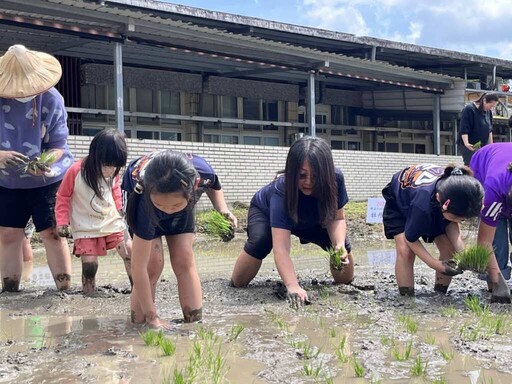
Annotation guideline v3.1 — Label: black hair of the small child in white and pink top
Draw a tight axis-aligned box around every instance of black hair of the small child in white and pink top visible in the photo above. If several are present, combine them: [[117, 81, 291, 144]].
[[82, 128, 128, 200]]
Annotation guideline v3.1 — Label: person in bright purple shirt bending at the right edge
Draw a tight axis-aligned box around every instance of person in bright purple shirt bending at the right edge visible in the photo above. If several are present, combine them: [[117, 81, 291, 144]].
[[470, 143, 512, 302]]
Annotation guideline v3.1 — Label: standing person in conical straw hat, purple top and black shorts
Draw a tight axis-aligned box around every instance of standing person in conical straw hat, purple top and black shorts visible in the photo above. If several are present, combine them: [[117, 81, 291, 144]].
[[0, 45, 73, 292]]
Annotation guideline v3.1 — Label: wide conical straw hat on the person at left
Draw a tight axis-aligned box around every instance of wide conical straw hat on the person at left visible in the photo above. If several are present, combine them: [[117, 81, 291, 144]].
[[0, 45, 62, 99]]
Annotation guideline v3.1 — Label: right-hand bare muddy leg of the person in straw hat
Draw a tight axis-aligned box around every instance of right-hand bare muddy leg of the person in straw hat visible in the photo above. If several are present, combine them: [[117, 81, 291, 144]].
[[40, 227, 71, 290]]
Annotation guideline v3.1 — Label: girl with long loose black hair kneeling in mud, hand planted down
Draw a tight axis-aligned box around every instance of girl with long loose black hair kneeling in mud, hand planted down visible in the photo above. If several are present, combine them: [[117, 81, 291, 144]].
[[231, 137, 354, 307]]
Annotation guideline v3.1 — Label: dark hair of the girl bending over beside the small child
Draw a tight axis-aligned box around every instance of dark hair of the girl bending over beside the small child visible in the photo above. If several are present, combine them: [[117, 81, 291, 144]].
[[126, 150, 199, 228]]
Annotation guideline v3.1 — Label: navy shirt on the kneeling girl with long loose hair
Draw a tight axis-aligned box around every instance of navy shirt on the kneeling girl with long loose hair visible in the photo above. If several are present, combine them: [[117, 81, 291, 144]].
[[251, 169, 348, 231]]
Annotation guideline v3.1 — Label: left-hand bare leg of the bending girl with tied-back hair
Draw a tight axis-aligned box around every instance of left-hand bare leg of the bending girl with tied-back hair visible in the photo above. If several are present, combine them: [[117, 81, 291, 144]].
[[395, 233, 416, 296]]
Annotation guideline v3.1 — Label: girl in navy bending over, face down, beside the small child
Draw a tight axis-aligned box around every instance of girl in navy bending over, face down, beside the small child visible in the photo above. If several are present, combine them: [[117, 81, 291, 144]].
[[121, 150, 237, 328]]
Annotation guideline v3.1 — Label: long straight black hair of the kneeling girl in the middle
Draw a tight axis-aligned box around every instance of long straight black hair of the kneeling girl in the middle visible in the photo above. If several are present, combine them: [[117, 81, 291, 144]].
[[284, 136, 338, 225]]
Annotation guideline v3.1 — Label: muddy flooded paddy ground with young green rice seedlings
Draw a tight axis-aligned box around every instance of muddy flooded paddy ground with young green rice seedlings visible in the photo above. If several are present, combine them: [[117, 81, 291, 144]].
[[0, 239, 512, 383]]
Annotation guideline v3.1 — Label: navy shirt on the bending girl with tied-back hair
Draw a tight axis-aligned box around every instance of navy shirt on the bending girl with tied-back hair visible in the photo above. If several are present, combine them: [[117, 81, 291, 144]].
[[391, 164, 450, 243]]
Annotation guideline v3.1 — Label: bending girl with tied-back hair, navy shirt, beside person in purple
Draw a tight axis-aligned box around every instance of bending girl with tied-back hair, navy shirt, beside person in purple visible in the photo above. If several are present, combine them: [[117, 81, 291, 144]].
[[382, 164, 484, 296]]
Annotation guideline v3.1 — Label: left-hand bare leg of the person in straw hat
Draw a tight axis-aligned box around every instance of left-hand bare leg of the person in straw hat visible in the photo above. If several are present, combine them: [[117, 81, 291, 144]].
[[0, 227, 25, 292]]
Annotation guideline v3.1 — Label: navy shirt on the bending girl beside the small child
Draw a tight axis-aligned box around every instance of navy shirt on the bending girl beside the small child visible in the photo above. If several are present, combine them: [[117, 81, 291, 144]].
[[121, 151, 221, 240]]
